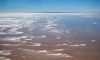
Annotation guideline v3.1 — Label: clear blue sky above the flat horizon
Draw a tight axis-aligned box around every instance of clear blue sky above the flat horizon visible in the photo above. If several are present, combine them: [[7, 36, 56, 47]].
[[0, 0, 100, 12]]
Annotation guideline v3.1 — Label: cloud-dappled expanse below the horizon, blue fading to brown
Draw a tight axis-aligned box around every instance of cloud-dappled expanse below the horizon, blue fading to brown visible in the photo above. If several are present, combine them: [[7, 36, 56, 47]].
[[0, 13, 100, 60]]
